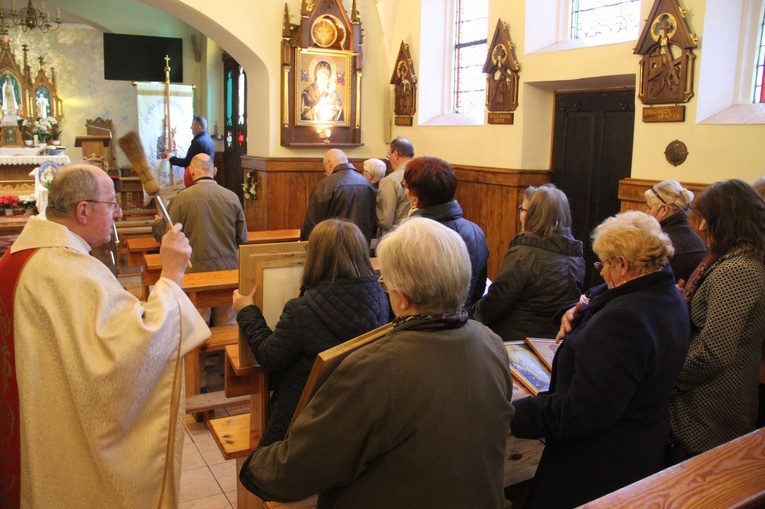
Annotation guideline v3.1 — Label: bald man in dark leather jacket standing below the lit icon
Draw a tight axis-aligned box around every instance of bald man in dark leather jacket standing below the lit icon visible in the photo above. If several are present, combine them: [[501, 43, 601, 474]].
[[300, 148, 377, 242]]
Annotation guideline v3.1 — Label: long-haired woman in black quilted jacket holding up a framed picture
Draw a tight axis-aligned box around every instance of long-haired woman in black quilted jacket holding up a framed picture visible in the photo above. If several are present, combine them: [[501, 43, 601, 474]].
[[234, 219, 388, 445]]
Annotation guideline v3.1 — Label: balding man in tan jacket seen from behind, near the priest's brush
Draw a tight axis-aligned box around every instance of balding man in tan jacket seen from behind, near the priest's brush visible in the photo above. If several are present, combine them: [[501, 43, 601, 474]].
[[152, 154, 247, 325]]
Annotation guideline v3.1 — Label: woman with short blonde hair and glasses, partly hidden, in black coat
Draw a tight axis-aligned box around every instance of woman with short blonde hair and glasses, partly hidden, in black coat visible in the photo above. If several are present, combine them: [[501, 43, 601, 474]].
[[645, 180, 707, 281]]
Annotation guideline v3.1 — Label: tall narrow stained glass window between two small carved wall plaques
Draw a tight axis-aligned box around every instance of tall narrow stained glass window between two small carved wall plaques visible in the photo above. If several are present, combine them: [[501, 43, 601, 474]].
[[453, 0, 489, 114]]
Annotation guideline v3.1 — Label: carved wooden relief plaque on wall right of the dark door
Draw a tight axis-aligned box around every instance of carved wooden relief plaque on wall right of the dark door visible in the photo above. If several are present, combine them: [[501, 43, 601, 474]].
[[635, 0, 698, 122]]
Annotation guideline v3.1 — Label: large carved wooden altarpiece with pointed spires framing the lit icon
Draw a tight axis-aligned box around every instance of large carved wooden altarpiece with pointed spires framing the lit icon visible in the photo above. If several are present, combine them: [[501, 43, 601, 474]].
[[281, 0, 363, 147]]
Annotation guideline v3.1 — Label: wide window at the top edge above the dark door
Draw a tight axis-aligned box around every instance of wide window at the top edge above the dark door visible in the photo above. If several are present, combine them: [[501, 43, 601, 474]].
[[570, 0, 640, 39]]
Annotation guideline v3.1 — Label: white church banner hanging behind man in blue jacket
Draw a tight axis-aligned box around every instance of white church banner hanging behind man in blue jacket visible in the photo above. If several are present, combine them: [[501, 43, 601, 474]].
[[136, 83, 194, 187]]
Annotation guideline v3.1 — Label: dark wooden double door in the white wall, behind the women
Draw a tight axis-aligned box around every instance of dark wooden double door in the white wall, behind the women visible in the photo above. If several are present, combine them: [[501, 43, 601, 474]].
[[552, 90, 635, 289]]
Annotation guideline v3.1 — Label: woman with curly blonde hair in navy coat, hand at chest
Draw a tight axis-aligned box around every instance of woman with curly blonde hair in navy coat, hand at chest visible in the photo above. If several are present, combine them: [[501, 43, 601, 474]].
[[511, 211, 690, 508]]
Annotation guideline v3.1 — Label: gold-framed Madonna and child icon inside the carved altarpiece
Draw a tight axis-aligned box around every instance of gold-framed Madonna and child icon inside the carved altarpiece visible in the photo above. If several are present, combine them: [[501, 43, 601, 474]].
[[295, 49, 351, 127]]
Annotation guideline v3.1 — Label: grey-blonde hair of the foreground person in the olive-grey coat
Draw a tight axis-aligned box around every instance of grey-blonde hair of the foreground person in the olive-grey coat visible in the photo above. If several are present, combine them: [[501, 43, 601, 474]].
[[377, 217, 471, 314]]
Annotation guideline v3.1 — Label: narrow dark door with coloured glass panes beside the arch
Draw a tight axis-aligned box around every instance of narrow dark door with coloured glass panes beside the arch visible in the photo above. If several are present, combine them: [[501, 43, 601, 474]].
[[222, 53, 247, 200]]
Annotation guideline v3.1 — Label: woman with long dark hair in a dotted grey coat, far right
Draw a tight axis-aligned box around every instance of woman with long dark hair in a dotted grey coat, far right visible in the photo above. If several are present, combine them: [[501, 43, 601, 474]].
[[670, 180, 765, 460]]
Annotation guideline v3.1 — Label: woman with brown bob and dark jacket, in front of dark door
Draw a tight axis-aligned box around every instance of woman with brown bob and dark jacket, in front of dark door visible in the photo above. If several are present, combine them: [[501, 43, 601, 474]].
[[474, 184, 584, 341]]
